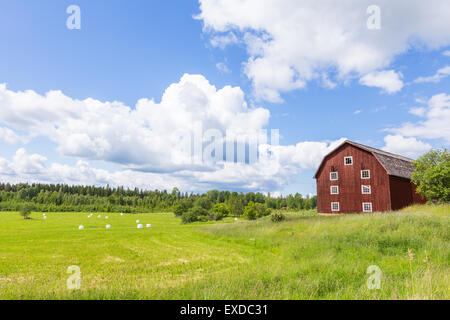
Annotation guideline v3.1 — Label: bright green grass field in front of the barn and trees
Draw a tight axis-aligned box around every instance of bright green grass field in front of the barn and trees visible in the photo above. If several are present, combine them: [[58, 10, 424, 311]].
[[0, 206, 450, 299]]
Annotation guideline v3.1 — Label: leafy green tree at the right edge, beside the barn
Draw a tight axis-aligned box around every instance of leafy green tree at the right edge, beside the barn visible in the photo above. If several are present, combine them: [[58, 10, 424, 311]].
[[411, 148, 450, 202]]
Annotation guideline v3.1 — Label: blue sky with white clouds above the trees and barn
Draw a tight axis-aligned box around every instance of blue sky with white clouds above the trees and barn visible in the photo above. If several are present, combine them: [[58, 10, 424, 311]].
[[0, 0, 450, 194]]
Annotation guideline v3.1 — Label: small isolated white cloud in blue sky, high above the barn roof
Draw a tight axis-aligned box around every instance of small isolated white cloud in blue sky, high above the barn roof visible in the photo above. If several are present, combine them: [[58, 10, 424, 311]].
[[359, 70, 403, 94]]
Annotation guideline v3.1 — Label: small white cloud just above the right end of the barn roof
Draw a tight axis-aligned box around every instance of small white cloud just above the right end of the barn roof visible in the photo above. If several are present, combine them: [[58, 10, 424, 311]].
[[383, 135, 431, 158]]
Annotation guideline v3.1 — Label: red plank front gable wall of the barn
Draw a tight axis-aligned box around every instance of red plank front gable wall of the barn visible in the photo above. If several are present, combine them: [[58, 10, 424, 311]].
[[317, 144, 390, 213]]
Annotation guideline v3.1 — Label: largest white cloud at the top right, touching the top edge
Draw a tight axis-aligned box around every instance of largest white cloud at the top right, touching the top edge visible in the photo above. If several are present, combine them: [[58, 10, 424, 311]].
[[197, 0, 450, 102]]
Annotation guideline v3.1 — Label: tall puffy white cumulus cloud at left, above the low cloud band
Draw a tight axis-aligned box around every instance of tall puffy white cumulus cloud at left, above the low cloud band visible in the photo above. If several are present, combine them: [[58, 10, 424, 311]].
[[0, 75, 270, 171]]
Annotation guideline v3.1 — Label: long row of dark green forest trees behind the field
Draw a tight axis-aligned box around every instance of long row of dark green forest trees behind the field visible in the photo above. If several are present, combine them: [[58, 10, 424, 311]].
[[0, 183, 317, 216]]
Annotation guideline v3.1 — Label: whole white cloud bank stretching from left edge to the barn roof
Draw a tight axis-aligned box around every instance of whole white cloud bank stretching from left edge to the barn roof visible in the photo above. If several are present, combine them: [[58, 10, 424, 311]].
[[0, 75, 346, 191]]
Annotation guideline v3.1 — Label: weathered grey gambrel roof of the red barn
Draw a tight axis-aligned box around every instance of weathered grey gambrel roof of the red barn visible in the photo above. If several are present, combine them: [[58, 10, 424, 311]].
[[314, 140, 414, 179]]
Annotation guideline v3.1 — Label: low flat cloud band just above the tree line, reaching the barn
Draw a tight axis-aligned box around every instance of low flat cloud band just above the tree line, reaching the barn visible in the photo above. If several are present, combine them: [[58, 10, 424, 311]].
[[0, 139, 345, 192]]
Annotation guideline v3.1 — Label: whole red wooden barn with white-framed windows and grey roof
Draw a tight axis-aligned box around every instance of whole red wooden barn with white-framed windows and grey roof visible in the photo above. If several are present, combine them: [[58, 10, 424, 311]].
[[314, 140, 425, 213]]
